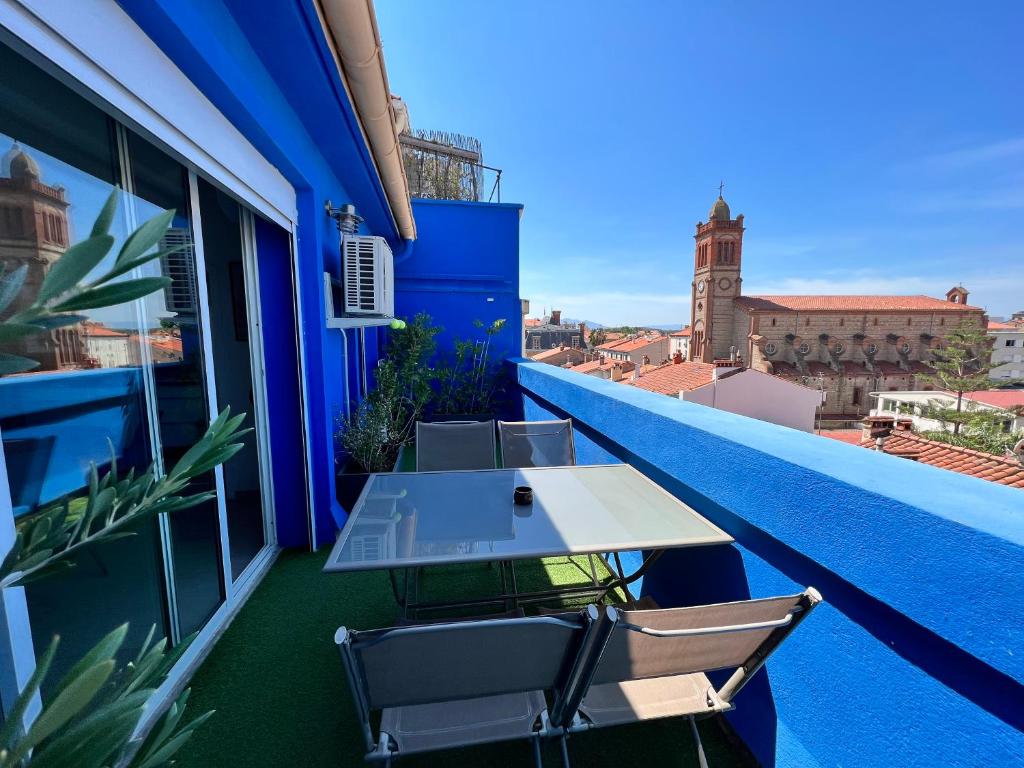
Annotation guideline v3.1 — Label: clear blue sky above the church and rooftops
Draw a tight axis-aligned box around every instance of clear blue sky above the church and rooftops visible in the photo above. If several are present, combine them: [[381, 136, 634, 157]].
[[377, 0, 1024, 325]]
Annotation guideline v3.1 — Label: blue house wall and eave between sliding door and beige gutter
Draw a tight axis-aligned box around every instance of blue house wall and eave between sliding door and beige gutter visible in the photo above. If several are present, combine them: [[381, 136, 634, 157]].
[[120, 0, 402, 546]]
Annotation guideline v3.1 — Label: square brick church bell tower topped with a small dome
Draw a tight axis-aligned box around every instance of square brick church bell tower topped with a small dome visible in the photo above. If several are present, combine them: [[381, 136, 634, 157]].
[[689, 185, 743, 362]]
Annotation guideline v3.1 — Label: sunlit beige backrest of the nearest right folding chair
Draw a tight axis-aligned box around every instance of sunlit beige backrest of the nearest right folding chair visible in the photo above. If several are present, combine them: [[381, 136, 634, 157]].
[[552, 587, 821, 725]]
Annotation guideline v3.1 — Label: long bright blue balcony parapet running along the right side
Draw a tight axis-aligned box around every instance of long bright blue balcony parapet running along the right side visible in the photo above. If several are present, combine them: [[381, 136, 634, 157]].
[[516, 360, 1024, 768]]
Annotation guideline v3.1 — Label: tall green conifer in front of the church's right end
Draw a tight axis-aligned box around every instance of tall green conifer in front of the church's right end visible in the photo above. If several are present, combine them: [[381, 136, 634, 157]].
[[924, 319, 993, 434]]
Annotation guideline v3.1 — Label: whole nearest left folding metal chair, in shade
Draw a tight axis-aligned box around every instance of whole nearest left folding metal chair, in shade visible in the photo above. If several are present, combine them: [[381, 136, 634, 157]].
[[335, 605, 600, 766]]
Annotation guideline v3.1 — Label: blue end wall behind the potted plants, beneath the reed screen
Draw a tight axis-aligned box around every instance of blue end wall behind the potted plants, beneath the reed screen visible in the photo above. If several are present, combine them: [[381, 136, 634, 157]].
[[395, 200, 522, 380]]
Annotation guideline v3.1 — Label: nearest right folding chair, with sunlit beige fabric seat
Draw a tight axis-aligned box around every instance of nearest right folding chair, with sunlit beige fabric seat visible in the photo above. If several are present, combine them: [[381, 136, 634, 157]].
[[551, 588, 821, 768]]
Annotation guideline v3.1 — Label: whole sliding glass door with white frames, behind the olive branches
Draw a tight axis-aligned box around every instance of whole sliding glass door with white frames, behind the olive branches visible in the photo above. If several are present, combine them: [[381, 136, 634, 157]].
[[0, 39, 273, 693]]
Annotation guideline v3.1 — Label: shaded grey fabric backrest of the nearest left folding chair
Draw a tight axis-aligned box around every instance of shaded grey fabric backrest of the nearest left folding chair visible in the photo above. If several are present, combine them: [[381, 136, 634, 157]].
[[335, 606, 597, 710]]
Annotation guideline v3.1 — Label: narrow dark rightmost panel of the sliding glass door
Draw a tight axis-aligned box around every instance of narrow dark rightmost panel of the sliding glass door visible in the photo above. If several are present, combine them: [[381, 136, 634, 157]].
[[199, 179, 266, 579]]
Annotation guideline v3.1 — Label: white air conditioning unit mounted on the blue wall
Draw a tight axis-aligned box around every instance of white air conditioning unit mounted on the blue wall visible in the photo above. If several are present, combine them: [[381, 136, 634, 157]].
[[341, 234, 394, 317]]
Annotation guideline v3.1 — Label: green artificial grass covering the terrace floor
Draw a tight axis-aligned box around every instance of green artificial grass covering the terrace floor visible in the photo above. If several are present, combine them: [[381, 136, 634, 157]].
[[177, 551, 753, 768]]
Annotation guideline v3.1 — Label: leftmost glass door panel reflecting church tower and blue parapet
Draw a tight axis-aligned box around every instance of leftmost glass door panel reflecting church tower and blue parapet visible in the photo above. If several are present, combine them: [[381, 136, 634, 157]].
[[0, 40, 168, 693]]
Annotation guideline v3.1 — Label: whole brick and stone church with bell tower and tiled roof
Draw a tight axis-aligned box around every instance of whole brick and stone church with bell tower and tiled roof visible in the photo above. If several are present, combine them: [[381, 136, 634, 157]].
[[688, 195, 987, 420]]
